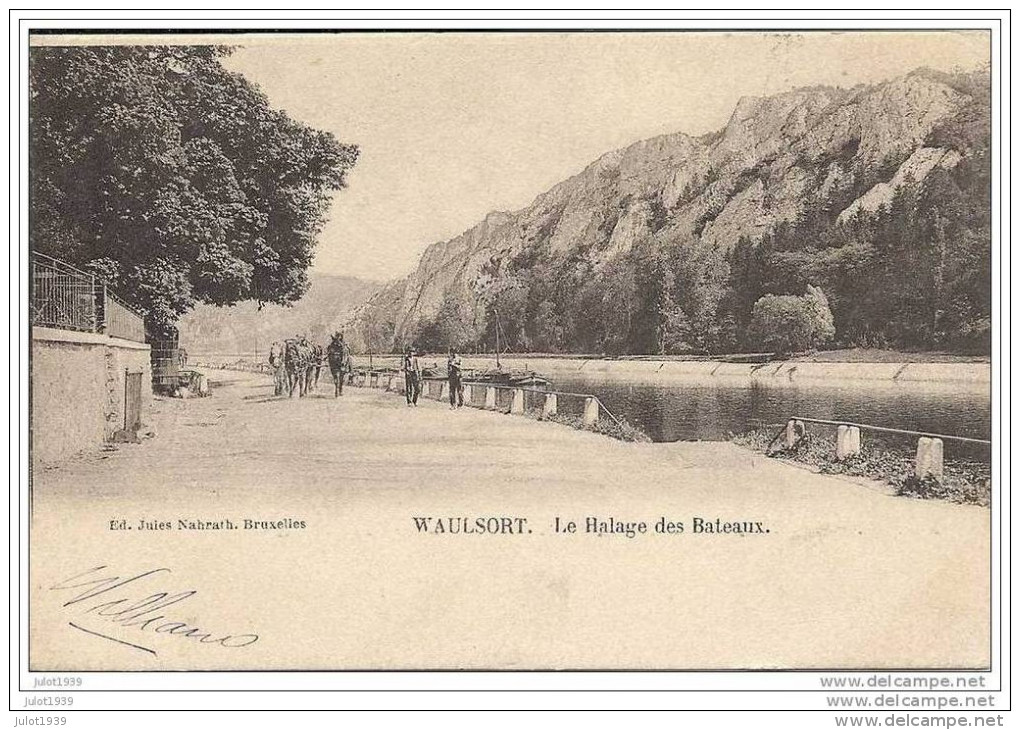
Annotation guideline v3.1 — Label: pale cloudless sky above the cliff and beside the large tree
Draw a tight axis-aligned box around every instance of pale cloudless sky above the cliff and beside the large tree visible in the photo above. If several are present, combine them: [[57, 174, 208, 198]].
[[215, 32, 989, 280]]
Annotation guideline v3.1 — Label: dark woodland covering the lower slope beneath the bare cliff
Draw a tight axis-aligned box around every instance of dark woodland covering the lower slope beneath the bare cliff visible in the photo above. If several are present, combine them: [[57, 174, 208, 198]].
[[465, 131, 991, 354]]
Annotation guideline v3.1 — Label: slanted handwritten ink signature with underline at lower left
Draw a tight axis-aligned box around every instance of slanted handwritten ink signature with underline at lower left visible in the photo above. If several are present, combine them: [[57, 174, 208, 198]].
[[50, 565, 259, 656]]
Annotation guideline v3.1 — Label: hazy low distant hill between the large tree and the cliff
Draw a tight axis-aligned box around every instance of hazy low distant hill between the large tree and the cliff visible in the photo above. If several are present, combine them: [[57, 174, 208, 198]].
[[177, 273, 381, 355]]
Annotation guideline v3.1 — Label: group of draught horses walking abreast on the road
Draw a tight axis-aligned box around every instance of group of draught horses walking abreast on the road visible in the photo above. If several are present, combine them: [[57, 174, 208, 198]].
[[269, 331, 353, 398]]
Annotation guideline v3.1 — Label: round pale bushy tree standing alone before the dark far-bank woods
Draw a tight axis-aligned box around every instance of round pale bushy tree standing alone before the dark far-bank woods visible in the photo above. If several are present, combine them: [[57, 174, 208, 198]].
[[751, 286, 835, 355]]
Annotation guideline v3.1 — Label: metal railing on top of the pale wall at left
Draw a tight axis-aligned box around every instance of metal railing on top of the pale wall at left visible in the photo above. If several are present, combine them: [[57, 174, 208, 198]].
[[29, 252, 145, 343]]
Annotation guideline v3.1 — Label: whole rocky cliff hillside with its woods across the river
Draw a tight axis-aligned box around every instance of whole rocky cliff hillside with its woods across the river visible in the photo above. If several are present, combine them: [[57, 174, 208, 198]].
[[353, 69, 991, 354]]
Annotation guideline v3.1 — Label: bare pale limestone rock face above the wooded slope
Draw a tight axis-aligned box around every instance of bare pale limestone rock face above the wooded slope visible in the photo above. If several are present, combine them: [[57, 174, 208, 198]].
[[356, 69, 986, 345]]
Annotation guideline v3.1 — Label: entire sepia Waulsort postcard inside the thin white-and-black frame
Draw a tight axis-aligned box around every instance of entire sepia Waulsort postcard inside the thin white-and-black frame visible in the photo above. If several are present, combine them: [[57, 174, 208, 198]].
[[26, 28, 1005, 672]]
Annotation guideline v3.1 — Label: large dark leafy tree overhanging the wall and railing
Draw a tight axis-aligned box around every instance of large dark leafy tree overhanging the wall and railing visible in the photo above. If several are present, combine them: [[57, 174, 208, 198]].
[[29, 46, 358, 331]]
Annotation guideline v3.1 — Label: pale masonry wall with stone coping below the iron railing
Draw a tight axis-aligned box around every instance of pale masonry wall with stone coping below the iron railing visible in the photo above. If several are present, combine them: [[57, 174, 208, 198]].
[[30, 327, 152, 462]]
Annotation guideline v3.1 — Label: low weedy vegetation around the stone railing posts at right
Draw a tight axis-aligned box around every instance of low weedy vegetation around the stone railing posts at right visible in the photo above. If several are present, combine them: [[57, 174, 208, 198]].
[[731, 426, 991, 507]]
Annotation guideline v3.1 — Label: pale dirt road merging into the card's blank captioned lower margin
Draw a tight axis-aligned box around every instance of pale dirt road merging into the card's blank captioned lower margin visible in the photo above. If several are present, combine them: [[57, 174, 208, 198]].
[[32, 371, 989, 670]]
